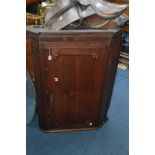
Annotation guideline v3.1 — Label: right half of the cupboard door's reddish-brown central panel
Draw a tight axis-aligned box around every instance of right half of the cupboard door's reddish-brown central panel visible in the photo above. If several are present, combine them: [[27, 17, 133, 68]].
[[76, 48, 109, 123]]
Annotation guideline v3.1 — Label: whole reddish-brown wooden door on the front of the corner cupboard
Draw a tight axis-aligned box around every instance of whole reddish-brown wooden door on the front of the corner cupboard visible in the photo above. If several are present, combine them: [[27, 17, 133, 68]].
[[45, 46, 109, 125]]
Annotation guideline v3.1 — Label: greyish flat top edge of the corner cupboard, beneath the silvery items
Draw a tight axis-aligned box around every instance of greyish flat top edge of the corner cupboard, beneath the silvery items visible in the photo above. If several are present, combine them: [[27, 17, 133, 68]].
[[26, 27, 120, 34]]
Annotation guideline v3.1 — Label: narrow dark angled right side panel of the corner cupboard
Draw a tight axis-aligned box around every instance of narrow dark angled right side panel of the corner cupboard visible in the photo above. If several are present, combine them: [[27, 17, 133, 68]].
[[100, 31, 122, 124]]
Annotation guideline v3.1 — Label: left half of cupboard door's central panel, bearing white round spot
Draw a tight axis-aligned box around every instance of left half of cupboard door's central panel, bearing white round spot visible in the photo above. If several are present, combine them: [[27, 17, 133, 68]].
[[47, 55, 76, 123]]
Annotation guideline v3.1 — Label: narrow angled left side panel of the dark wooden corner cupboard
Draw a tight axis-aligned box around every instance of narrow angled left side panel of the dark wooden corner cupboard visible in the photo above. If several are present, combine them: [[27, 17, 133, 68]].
[[30, 33, 48, 129]]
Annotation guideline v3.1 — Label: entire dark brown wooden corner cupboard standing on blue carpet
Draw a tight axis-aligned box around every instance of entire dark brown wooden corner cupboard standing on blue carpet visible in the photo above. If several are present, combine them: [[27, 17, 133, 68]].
[[27, 28, 121, 132]]
